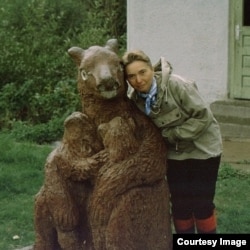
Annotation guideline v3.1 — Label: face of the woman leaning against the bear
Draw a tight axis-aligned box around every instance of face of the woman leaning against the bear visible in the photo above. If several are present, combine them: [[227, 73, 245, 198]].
[[125, 61, 154, 93]]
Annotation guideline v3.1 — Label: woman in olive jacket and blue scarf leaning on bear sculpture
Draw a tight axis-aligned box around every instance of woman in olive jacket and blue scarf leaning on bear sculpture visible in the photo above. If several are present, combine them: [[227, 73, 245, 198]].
[[122, 50, 222, 233]]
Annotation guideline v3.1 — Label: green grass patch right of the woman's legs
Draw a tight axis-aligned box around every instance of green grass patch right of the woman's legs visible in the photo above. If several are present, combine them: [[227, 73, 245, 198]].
[[215, 163, 250, 234]]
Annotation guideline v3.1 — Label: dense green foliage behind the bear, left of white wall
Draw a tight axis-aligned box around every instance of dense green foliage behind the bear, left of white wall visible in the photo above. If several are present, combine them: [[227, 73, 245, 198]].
[[0, 0, 126, 141]]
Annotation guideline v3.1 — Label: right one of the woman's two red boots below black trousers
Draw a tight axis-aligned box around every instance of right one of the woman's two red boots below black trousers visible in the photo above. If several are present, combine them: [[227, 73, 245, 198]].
[[195, 212, 217, 234]]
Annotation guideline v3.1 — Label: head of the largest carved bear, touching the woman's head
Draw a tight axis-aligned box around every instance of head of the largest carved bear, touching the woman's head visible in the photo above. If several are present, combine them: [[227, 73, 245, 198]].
[[68, 39, 127, 99]]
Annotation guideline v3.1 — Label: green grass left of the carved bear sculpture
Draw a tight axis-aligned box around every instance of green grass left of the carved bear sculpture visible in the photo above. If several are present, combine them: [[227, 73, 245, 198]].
[[0, 134, 51, 250]]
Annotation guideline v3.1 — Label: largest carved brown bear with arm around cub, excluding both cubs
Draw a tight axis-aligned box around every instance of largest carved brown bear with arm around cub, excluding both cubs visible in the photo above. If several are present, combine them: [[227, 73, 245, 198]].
[[68, 39, 172, 250]]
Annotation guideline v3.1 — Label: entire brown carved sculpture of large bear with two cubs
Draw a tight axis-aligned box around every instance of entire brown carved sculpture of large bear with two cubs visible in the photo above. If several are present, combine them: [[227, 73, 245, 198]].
[[34, 39, 172, 250]]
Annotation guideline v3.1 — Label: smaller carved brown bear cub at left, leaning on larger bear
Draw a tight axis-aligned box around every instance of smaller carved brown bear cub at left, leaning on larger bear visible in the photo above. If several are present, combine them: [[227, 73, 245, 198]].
[[34, 112, 102, 250]]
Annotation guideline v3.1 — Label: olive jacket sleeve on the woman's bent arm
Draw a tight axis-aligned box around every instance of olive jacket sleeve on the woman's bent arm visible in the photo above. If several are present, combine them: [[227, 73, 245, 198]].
[[168, 79, 213, 142]]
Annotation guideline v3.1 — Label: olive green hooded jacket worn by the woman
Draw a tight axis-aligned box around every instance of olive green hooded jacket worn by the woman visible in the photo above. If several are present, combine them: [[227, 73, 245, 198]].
[[130, 57, 222, 160]]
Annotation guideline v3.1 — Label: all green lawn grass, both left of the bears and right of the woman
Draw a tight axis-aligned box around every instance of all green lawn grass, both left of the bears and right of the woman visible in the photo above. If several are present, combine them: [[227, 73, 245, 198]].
[[0, 134, 250, 250]]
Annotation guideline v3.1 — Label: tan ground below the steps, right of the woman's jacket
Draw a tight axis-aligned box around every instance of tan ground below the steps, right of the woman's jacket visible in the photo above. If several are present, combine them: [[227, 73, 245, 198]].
[[222, 139, 250, 173]]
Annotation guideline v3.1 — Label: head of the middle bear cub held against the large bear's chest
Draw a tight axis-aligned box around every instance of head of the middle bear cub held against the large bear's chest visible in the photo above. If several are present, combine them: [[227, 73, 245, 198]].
[[98, 116, 139, 162]]
